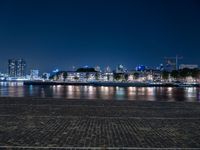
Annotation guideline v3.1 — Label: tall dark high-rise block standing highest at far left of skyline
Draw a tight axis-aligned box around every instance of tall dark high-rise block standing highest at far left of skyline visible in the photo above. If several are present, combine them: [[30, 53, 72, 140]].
[[8, 59, 26, 77]]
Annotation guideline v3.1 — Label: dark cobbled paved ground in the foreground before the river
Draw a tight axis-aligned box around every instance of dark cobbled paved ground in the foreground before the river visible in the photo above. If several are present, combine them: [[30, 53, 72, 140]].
[[0, 98, 200, 149]]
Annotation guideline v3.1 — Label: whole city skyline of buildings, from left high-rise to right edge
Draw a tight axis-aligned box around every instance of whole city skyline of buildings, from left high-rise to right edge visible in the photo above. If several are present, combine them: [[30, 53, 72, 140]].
[[0, 57, 199, 82]]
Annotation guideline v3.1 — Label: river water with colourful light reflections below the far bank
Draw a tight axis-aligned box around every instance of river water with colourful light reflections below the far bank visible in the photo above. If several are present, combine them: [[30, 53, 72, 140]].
[[0, 82, 200, 102]]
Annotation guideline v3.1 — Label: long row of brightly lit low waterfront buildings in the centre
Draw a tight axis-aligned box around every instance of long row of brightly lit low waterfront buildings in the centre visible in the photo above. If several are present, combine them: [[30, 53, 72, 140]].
[[52, 65, 161, 82]]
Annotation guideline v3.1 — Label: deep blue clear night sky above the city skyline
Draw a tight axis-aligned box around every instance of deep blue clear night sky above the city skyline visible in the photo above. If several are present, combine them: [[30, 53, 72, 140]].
[[0, 0, 200, 71]]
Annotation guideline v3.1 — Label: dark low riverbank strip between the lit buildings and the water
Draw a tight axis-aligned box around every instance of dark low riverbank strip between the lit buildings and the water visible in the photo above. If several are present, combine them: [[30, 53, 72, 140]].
[[24, 81, 200, 87]]
